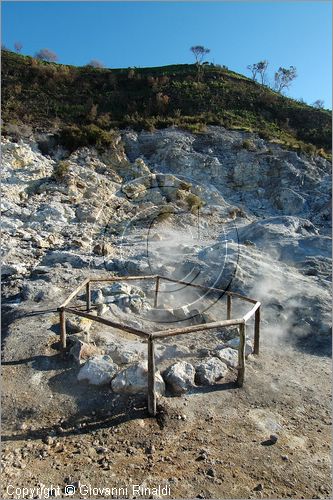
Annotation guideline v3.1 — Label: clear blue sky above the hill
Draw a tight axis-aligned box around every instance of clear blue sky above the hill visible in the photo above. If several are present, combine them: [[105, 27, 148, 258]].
[[2, 0, 332, 108]]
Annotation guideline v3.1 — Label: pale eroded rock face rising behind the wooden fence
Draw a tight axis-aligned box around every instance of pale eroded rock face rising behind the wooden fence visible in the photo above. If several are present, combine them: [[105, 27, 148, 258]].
[[2, 127, 331, 406]]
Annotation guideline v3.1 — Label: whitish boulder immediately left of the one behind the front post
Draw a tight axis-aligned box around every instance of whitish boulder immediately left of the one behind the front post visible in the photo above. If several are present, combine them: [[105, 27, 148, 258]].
[[77, 356, 118, 385]]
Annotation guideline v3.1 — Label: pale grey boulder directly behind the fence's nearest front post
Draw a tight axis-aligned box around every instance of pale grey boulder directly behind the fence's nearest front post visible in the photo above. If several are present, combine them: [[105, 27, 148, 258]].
[[111, 363, 165, 395]]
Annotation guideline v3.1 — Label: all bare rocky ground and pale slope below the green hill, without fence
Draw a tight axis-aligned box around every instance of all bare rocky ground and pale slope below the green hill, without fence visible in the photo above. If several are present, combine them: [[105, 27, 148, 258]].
[[2, 126, 331, 498]]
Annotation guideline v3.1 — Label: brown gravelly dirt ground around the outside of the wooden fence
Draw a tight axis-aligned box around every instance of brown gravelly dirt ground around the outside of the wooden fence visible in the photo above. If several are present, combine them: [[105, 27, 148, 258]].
[[1, 300, 332, 499]]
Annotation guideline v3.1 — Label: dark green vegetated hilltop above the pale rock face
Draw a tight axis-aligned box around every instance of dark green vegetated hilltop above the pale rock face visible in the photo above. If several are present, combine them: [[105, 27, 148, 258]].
[[2, 50, 331, 156]]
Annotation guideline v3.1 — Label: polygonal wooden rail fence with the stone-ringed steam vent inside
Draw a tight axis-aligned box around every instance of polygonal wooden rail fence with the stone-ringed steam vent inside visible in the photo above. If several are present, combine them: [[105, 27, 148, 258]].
[[58, 275, 260, 416]]
